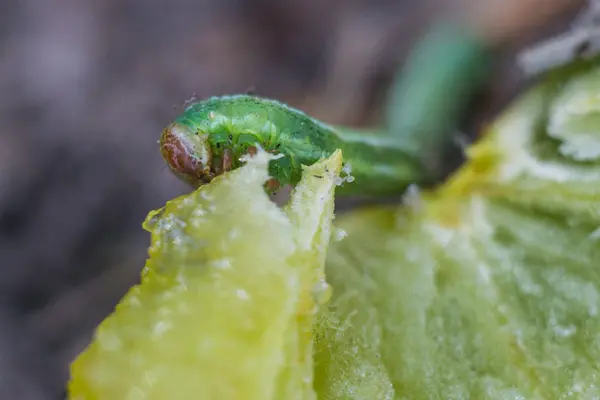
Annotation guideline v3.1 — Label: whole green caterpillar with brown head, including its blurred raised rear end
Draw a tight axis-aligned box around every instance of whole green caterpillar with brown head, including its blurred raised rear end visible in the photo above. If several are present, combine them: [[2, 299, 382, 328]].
[[161, 24, 490, 197]]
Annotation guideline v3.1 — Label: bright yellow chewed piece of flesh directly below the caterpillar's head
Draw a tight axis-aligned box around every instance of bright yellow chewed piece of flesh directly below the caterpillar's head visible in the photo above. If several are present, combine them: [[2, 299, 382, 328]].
[[69, 152, 342, 400]]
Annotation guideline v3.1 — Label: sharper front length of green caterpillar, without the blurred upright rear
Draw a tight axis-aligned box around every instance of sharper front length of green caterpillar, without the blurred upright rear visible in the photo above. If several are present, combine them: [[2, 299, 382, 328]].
[[160, 95, 427, 196]]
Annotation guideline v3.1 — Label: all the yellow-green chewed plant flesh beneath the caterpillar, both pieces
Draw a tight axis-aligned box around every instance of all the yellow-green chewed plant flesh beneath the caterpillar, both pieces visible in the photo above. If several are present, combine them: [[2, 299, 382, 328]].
[[71, 59, 600, 399]]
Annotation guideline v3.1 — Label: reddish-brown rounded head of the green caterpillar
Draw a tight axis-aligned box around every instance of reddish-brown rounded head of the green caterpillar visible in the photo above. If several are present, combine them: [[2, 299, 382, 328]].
[[160, 122, 218, 187]]
